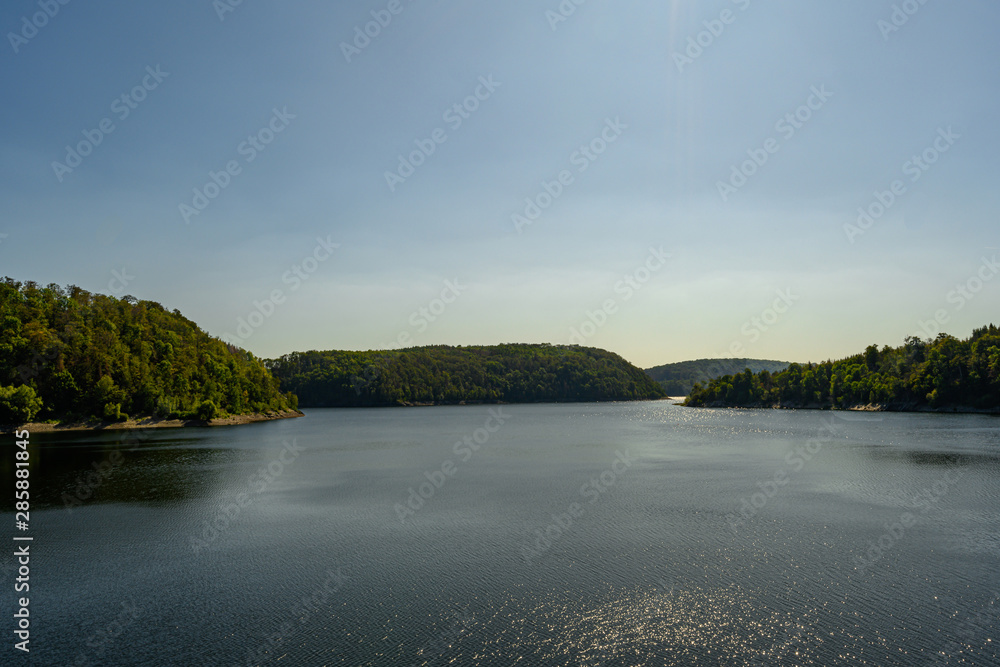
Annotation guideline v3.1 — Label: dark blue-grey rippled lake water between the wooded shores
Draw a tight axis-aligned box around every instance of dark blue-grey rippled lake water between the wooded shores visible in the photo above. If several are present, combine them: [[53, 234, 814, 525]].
[[0, 402, 1000, 667]]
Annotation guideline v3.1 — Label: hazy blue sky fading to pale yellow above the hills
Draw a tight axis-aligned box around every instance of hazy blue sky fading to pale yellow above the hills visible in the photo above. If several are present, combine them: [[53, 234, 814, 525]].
[[0, 0, 1000, 367]]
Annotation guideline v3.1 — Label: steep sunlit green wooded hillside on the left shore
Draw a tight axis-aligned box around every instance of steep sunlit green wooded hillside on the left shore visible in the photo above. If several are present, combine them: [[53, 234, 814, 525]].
[[0, 278, 295, 424]]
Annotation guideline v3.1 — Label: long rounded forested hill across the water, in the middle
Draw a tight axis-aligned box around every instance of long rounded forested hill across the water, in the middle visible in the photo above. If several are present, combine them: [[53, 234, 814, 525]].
[[267, 344, 664, 407]]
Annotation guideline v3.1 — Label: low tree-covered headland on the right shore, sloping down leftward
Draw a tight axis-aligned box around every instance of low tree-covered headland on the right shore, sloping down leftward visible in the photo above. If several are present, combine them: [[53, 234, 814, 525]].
[[685, 324, 1000, 411]]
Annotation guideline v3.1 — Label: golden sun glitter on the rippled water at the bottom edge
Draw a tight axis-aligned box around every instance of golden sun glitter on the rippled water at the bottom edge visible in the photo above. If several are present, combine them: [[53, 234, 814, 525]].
[[449, 585, 822, 667]]
